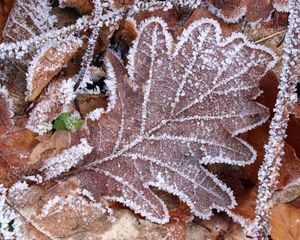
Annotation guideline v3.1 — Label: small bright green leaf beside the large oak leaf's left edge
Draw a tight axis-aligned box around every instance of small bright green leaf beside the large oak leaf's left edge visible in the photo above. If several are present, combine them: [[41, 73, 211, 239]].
[[53, 112, 83, 130]]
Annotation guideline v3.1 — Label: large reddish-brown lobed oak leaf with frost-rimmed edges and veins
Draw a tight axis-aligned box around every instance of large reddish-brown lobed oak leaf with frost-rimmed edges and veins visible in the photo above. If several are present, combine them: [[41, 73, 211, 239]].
[[73, 18, 276, 223]]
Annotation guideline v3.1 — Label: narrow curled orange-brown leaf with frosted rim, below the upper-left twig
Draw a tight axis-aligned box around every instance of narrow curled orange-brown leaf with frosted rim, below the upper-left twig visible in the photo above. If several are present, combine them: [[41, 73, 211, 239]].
[[26, 38, 81, 102]]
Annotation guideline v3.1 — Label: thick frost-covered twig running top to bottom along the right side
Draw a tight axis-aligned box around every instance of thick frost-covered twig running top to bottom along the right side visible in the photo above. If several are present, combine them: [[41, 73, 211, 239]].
[[254, 0, 300, 239]]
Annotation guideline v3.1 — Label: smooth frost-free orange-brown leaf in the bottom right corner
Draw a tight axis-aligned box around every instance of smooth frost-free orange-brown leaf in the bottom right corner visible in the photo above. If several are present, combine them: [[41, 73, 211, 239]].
[[271, 204, 300, 240]]
